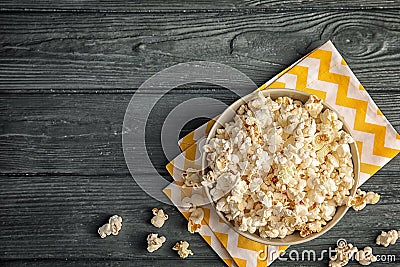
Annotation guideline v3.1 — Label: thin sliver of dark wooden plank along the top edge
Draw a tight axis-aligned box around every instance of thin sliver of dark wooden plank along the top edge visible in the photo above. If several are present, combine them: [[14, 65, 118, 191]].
[[0, 0, 400, 12]]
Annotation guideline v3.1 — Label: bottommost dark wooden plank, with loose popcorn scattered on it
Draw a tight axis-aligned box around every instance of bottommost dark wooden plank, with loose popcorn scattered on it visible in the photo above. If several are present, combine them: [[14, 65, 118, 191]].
[[0, 172, 400, 266]]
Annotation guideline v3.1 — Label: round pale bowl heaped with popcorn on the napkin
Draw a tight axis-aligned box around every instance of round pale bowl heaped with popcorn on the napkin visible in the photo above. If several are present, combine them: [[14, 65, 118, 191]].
[[202, 89, 359, 245]]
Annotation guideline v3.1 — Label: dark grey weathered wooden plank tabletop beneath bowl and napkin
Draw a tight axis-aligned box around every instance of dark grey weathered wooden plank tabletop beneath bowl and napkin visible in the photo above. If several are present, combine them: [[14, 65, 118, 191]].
[[0, 0, 400, 266]]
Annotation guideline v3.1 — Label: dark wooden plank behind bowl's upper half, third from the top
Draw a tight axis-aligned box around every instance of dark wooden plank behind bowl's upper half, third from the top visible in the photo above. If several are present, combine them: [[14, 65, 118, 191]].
[[0, 92, 400, 175]]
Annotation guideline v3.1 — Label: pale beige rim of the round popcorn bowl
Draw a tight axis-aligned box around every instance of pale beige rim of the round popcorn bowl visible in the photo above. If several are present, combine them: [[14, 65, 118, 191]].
[[201, 88, 360, 246]]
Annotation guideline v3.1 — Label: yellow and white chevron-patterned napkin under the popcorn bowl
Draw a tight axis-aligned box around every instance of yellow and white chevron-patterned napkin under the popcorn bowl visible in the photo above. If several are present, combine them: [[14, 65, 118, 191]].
[[164, 41, 400, 267]]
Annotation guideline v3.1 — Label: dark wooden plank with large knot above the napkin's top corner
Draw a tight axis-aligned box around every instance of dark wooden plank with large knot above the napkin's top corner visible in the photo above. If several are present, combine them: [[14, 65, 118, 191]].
[[0, 11, 400, 92]]
